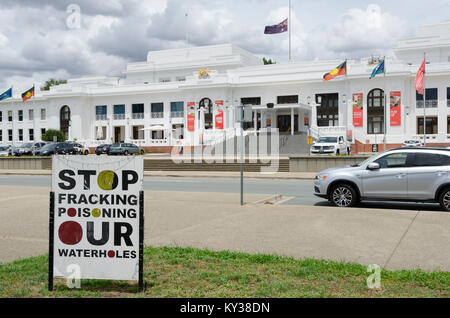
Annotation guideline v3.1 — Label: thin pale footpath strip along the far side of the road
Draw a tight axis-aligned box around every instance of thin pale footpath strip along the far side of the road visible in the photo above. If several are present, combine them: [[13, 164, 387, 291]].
[[0, 169, 317, 180]]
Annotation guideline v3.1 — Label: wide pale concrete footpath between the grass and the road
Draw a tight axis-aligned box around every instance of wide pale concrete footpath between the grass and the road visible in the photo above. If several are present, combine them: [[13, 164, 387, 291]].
[[0, 187, 450, 271]]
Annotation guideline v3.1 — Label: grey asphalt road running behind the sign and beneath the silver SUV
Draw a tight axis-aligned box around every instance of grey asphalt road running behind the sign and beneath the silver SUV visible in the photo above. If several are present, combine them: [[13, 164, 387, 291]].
[[0, 175, 440, 211]]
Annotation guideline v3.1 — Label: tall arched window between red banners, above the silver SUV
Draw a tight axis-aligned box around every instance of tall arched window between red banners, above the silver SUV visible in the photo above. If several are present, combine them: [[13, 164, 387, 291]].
[[367, 88, 384, 134]]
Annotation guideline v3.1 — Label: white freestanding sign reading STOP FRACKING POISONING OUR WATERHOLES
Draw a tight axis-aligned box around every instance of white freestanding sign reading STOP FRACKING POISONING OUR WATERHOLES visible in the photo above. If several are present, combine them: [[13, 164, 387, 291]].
[[49, 156, 144, 290]]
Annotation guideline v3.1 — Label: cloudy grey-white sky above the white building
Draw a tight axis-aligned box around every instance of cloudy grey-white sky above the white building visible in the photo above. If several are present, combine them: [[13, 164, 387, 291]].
[[0, 0, 450, 93]]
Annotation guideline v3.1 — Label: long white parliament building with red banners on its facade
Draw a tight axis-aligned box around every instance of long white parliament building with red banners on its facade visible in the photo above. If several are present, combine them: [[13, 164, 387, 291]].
[[0, 23, 450, 152]]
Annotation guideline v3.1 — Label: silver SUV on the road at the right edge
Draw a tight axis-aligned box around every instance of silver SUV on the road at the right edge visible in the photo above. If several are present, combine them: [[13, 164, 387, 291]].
[[314, 147, 450, 211]]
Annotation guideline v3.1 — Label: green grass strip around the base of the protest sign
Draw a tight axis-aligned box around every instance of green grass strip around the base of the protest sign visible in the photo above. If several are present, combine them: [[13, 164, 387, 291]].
[[0, 247, 450, 298]]
